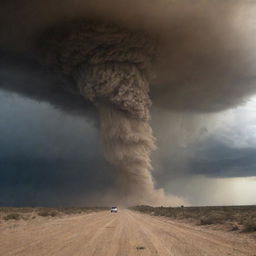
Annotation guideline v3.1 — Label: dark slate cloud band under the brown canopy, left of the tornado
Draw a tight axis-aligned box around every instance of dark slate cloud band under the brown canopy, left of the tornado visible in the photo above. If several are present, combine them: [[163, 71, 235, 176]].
[[0, 51, 95, 120]]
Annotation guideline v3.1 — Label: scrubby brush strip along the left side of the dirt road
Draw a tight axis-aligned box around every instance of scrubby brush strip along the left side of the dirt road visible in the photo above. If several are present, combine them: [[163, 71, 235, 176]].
[[0, 207, 108, 221]]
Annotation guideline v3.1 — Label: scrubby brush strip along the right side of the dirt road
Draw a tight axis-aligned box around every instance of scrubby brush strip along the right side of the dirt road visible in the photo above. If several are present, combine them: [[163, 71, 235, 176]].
[[131, 205, 256, 232]]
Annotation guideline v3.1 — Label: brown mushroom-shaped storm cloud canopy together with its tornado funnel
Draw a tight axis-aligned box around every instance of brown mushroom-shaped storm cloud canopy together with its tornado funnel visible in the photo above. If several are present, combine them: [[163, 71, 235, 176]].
[[0, 0, 256, 204]]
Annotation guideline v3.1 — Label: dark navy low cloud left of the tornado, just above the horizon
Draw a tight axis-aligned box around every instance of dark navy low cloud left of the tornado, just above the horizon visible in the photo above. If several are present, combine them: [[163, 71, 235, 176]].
[[0, 155, 114, 206]]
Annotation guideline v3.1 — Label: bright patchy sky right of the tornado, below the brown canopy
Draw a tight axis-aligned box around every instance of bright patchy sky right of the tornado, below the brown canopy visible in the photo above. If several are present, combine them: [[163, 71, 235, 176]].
[[152, 96, 256, 205]]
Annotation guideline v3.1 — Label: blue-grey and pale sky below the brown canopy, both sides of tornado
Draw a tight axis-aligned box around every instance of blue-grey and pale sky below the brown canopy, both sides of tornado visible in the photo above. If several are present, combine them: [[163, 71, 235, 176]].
[[0, 90, 256, 206]]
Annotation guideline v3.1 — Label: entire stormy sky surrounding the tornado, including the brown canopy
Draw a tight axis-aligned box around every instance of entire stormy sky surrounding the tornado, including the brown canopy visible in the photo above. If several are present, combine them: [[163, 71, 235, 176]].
[[0, 0, 256, 206]]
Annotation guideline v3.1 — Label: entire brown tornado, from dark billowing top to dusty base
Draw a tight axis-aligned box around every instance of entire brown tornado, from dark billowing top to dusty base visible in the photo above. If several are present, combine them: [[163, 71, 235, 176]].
[[40, 21, 164, 205]]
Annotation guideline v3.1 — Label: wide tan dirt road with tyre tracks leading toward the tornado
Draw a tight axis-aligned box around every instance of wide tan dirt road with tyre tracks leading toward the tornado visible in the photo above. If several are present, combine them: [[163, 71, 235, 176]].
[[0, 210, 256, 256]]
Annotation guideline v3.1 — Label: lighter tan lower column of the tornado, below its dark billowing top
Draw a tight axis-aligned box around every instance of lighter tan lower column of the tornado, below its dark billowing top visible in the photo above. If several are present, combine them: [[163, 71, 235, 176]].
[[97, 104, 167, 205]]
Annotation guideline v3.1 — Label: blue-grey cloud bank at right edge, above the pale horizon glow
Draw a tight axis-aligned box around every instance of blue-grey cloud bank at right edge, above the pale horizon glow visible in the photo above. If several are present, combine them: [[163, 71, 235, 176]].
[[190, 140, 256, 177]]
